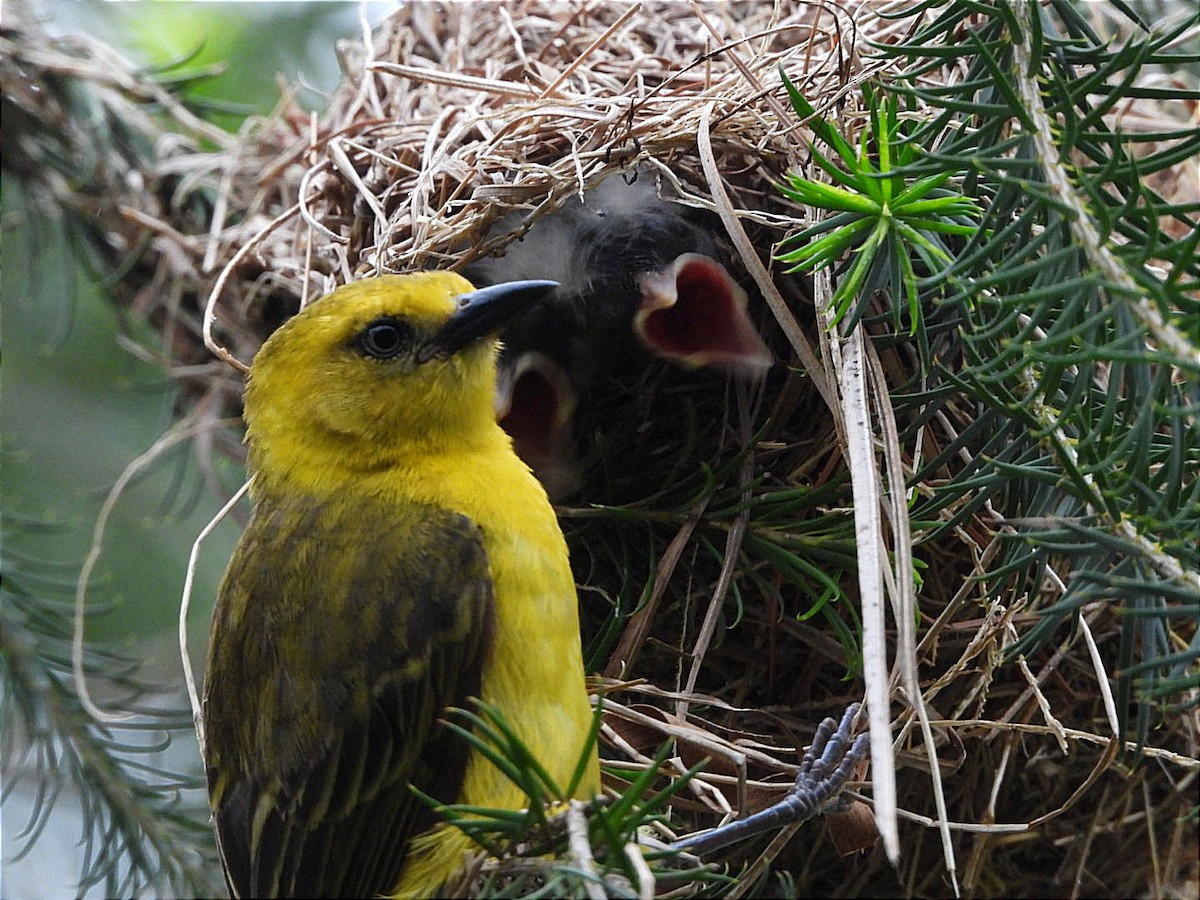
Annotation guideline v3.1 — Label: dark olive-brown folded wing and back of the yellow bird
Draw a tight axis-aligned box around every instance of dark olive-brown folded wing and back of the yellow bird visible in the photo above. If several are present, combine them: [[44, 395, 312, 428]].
[[204, 500, 493, 896]]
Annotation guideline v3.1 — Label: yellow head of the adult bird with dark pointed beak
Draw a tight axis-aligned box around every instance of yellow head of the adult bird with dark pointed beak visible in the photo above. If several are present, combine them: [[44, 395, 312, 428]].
[[245, 272, 554, 489]]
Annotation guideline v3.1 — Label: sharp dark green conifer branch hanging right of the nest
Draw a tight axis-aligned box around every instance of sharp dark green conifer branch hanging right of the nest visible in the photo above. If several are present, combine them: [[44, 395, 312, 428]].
[[868, 2, 1200, 738]]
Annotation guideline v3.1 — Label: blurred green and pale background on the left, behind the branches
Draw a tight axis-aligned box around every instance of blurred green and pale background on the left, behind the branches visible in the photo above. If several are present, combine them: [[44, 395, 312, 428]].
[[0, 0, 395, 900]]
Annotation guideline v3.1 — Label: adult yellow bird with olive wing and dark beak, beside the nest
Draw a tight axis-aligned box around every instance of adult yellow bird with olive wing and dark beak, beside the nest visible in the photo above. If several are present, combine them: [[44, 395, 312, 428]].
[[203, 272, 600, 896]]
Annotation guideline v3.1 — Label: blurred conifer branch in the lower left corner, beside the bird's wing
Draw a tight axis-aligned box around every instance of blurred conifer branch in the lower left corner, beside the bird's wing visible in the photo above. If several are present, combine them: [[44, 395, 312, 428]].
[[0, 573, 220, 895]]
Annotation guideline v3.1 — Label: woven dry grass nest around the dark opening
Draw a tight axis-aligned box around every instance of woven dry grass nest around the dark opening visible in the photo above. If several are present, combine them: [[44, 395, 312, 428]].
[[23, 2, 1187, 895]]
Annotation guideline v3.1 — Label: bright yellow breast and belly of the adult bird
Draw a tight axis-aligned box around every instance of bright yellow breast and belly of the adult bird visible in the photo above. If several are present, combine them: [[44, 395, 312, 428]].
[[298, 434, 600, 896]]
